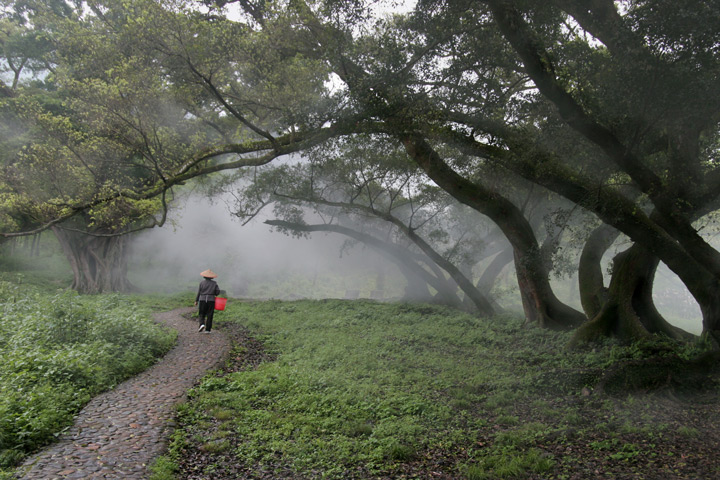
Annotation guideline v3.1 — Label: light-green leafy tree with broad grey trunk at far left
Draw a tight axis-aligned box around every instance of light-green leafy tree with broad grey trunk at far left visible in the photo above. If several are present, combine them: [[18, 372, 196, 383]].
[[2, 1, 198, 293]]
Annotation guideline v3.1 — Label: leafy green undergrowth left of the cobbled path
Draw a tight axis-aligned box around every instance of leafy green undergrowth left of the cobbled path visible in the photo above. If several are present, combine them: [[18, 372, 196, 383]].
[[0, 275, 175, 477]]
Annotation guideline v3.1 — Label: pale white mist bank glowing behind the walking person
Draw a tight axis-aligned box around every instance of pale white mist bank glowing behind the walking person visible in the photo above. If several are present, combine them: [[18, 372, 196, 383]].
[[128, 192, 404, 299]]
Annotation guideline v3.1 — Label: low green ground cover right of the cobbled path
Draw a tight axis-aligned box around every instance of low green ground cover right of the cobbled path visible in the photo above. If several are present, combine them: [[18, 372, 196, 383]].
[[159, 300, 720, 479]]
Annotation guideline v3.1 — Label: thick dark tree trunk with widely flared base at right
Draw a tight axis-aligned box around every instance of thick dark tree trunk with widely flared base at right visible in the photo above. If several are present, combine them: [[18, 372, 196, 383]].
[[571, 244, 691, 345]]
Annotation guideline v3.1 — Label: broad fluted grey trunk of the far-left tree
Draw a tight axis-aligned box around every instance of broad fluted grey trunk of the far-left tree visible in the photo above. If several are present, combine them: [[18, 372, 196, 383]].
[[52, 226, 135, 294]]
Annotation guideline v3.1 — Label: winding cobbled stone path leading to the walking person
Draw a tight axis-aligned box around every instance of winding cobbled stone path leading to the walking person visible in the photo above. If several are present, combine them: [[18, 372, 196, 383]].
[[18, 308, 230, 480]]
